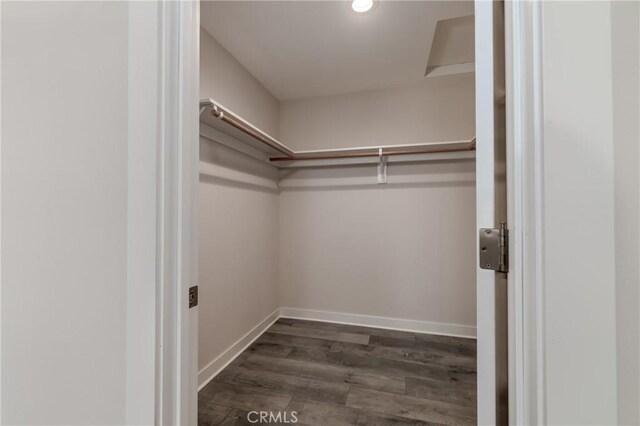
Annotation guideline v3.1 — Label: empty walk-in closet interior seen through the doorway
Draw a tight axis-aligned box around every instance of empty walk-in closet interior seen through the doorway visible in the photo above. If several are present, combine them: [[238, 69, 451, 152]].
[[197, 0, 477, 425]]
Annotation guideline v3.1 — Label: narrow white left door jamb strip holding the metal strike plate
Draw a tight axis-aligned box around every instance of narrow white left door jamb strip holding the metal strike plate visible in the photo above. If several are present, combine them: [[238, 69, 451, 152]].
[[173, 1, 200, 425]]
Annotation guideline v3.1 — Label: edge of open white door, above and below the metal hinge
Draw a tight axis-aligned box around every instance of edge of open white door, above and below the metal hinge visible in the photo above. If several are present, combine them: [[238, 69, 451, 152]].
[[475, 1, 508, 424]]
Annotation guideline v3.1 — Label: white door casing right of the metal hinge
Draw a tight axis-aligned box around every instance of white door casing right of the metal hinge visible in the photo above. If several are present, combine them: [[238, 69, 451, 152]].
[[506, 1, 546, 424]]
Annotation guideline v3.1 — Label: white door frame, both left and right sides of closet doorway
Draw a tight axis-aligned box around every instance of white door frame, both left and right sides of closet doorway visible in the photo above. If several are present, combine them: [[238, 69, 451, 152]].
[[156, 0, 546, 424]]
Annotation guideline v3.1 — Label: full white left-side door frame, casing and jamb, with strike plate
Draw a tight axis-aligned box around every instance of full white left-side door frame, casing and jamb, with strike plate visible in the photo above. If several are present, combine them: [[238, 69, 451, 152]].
[[155, 1, 200, 424]]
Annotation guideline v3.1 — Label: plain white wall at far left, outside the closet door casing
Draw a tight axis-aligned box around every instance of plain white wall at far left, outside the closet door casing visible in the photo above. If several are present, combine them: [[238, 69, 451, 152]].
[[1, 2, 129, 424]]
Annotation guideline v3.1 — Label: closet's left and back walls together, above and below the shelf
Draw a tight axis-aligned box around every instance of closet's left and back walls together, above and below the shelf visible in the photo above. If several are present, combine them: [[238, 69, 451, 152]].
[[199, 31, 475, 380]]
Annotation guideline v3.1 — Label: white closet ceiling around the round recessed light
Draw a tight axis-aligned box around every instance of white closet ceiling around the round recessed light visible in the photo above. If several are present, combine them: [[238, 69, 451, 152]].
[[201, 0, 473, 100]]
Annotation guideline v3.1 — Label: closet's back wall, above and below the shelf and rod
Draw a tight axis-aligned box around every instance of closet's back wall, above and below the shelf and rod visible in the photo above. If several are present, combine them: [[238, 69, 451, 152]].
[[280, 70, 476, 332]]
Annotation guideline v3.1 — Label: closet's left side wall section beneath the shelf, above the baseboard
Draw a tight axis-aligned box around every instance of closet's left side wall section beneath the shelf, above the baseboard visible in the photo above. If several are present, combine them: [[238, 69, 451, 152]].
[[198, 138, 278, 370]]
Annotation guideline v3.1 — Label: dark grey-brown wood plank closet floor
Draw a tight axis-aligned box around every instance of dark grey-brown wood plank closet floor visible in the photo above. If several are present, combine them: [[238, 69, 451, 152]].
[[198, 318, 476, 426]]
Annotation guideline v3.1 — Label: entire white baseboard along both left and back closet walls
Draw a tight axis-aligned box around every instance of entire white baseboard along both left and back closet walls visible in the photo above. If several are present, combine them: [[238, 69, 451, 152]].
[[198, 308, 476, 390]]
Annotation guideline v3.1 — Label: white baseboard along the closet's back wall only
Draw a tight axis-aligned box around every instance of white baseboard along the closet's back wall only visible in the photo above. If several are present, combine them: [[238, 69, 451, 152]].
[[280, 308, 476, 339]]
